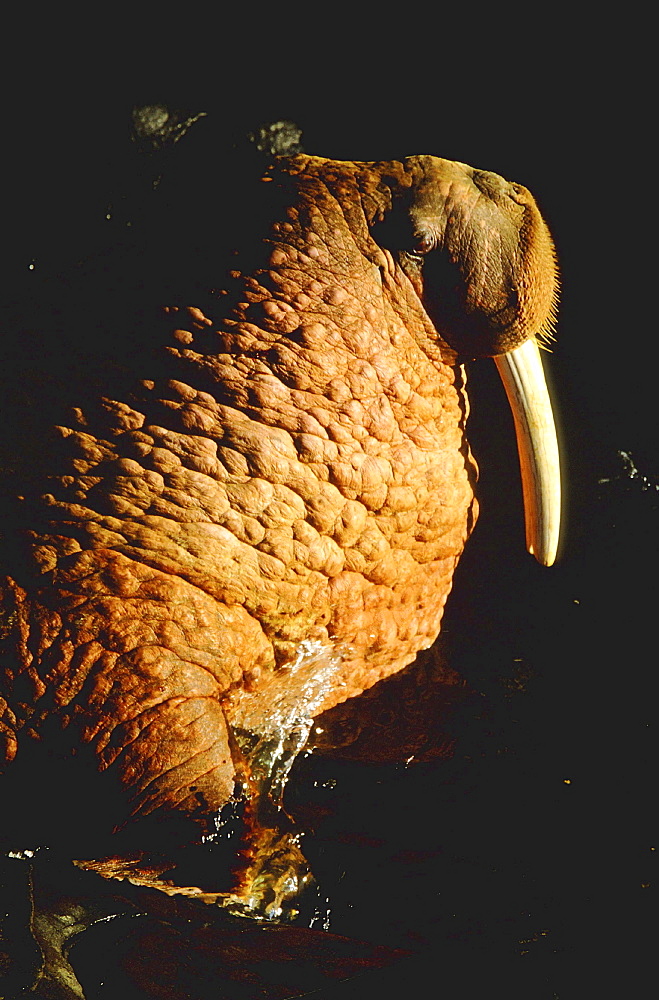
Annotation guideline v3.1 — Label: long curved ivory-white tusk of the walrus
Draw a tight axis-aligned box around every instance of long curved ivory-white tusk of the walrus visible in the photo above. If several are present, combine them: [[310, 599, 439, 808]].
[[494, 337, 561, 566]]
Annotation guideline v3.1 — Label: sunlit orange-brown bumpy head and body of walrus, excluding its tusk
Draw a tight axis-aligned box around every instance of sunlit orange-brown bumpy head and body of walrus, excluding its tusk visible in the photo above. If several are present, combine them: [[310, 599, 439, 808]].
[[0, 156, 554, 840]]
